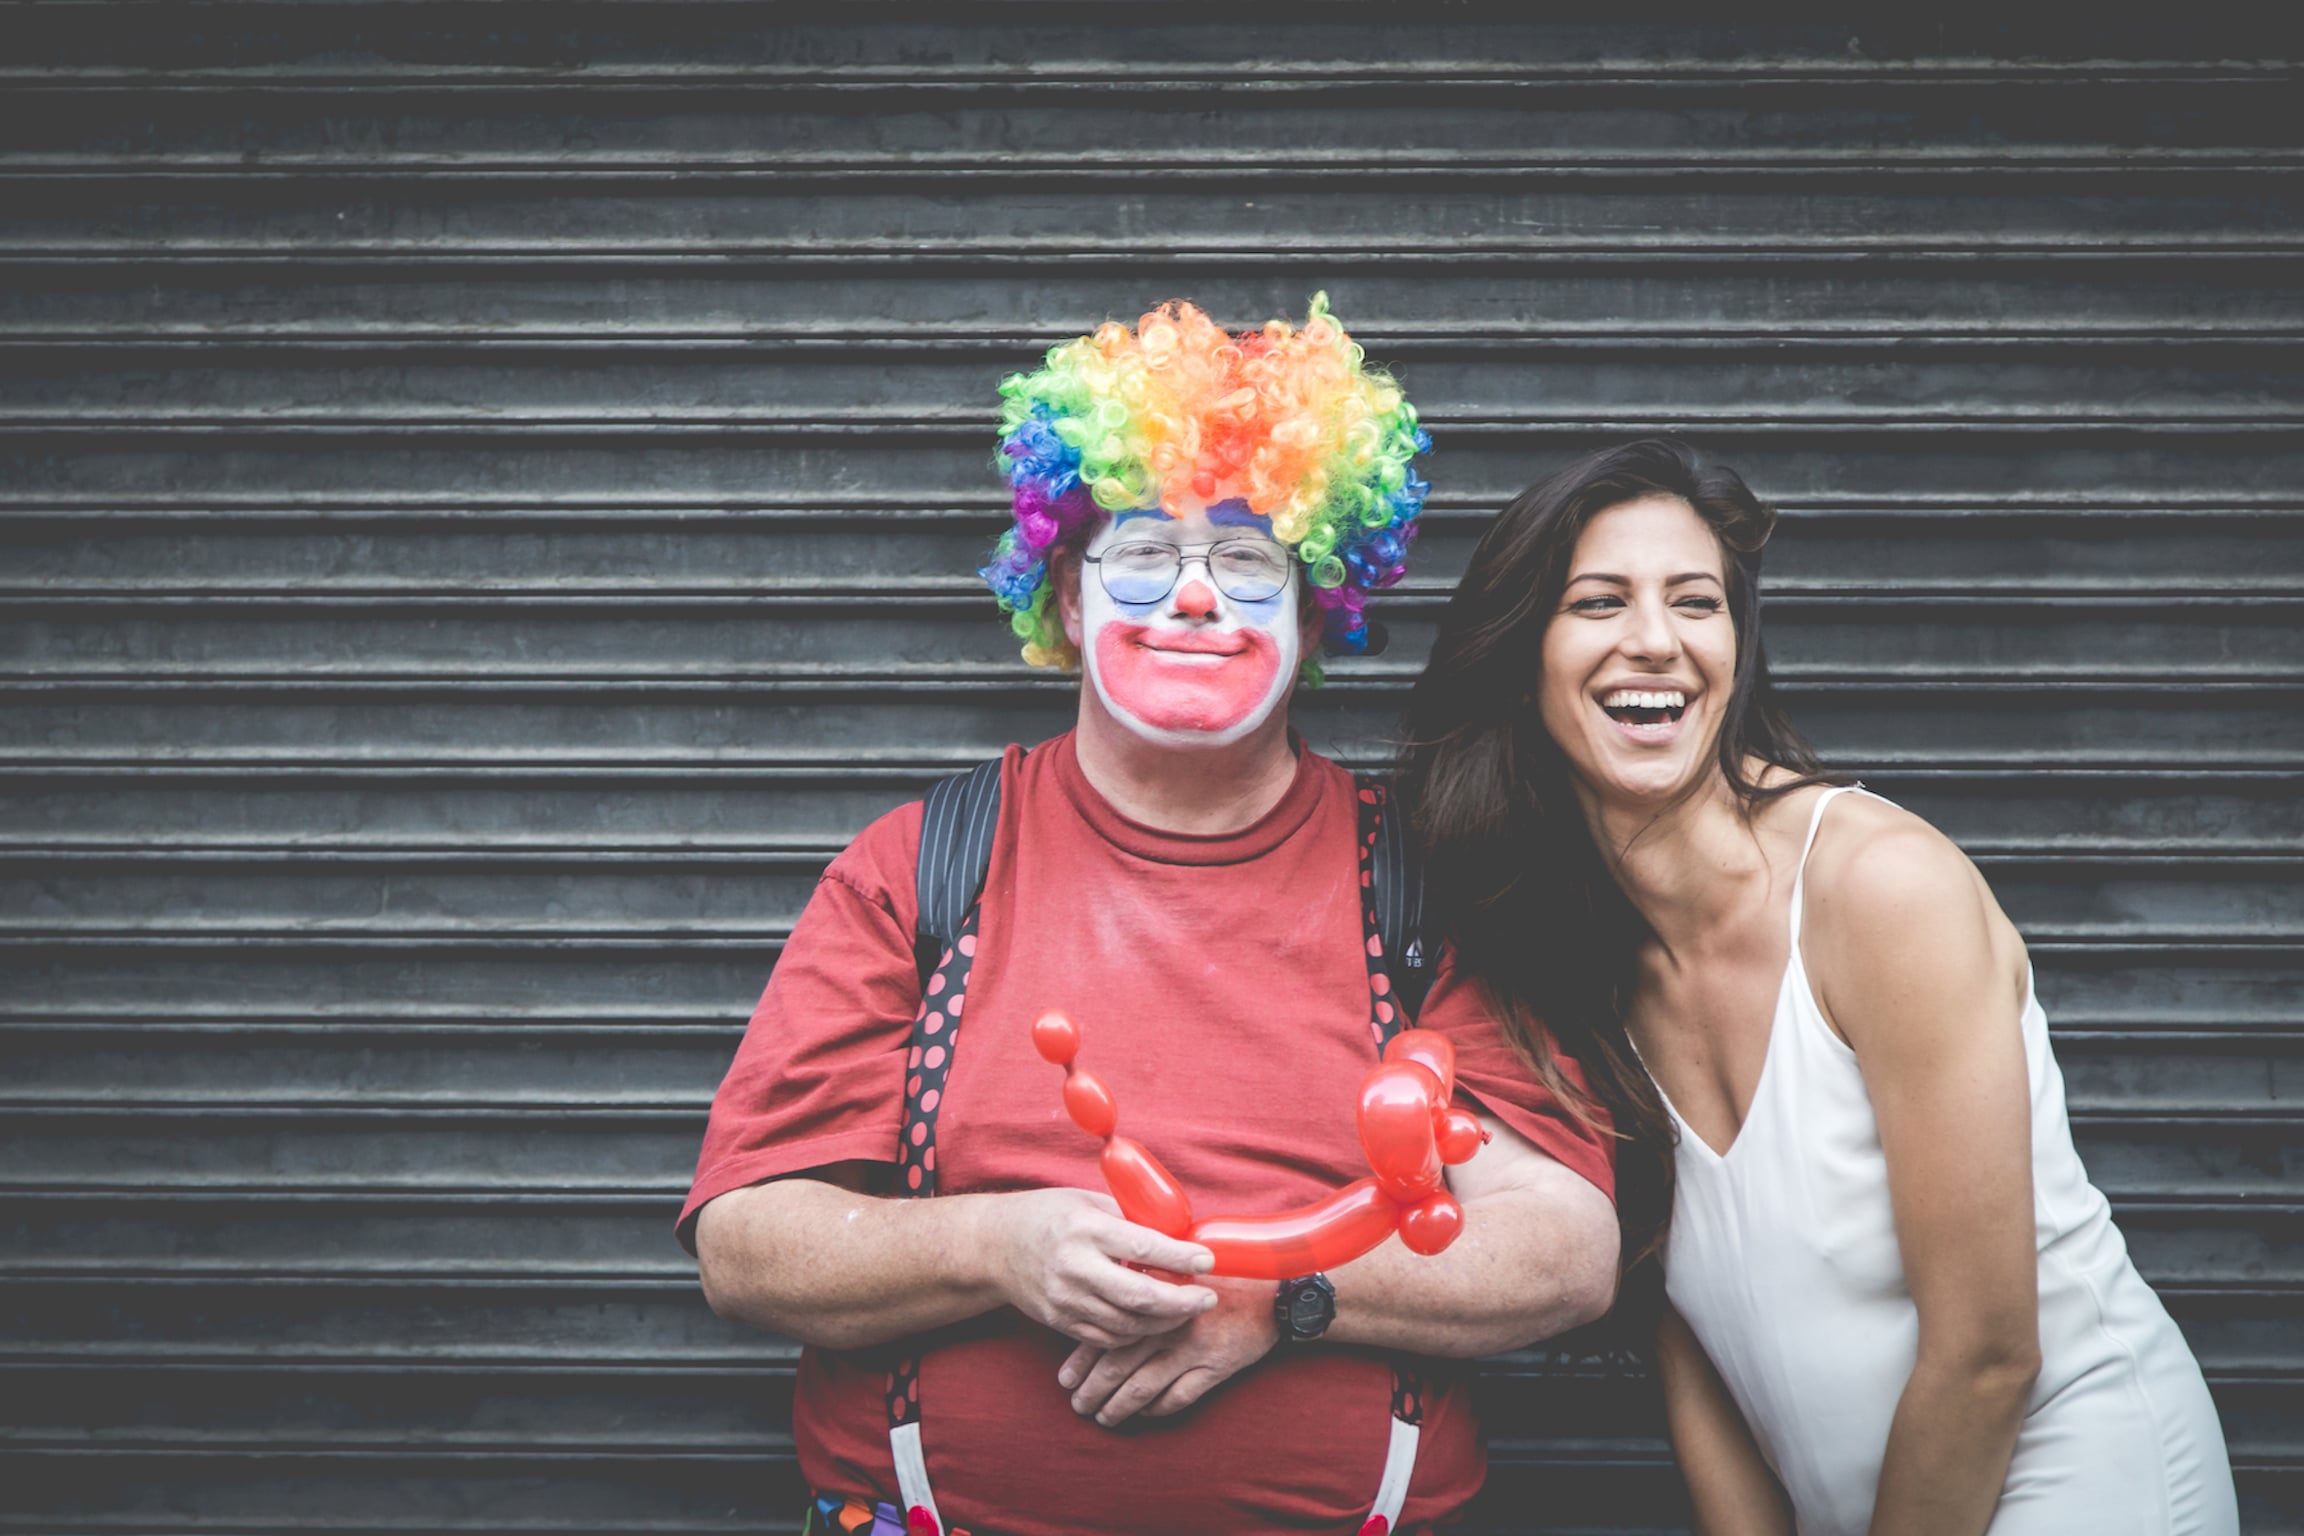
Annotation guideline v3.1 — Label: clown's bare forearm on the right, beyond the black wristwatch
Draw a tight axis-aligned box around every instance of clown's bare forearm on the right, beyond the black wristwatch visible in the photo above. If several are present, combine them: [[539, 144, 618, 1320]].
[[1327, 1174, 1617, 1359]]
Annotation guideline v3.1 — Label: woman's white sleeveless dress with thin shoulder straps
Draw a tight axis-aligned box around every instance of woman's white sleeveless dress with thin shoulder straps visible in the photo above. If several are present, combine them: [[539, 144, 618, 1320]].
[[1659, 785, 2239, 1536]]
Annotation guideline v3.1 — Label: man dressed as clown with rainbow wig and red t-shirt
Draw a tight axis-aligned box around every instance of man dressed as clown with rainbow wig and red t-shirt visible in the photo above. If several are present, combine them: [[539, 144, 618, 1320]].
[[680, 299, 1617, 1536]]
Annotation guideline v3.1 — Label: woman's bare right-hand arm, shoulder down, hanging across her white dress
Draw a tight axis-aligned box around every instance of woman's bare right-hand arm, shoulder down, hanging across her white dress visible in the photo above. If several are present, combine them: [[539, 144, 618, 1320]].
[[1804, 801, 2039, 1536]]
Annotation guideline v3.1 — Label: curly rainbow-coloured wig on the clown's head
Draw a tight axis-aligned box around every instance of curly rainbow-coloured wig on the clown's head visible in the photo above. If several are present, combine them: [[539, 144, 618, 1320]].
[[979, 292, 1431, 682]]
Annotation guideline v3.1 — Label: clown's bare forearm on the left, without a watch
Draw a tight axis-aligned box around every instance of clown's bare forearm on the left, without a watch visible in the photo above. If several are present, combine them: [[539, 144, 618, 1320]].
[[696, 1179, 1005, 1349]]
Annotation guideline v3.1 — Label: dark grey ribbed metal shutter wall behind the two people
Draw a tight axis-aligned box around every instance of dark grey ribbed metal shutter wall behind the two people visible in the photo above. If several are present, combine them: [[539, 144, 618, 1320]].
[[0, 0, 2304, 1536]]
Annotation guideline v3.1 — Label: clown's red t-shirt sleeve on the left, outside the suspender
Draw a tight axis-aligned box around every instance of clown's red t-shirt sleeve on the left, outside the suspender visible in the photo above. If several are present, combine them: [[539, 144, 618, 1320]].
[[677, 804, 919, 1253]]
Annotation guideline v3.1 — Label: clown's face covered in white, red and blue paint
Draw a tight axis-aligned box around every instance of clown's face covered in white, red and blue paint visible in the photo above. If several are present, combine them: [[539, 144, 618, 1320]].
[[1074, 502, 1302, 746]]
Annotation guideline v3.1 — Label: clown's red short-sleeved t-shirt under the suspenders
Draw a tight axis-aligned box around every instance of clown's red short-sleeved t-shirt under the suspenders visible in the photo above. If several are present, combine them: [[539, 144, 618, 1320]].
[[680, 735, 1615, 1536]]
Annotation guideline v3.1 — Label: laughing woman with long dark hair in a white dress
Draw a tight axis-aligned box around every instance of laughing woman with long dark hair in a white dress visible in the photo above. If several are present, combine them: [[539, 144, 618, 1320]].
[[1401, 442, 2237, 1536]]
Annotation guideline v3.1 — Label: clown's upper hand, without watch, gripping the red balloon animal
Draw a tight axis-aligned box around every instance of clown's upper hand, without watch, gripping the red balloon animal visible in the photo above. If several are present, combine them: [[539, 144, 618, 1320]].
[[986, 1188, 1217, 1349]]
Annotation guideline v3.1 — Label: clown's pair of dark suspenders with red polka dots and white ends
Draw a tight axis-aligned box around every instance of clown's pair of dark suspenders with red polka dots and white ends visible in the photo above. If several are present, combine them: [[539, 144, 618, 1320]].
[[887, 781, 1424, 1536]]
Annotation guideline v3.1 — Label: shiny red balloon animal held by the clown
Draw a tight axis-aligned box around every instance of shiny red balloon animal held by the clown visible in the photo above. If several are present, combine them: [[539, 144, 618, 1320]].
[[1032, 1013, 1488, 1280]]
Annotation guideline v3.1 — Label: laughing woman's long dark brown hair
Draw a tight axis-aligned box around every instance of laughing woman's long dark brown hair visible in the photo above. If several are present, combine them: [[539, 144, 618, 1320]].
[[1399, 438, 1822, 1299]]
